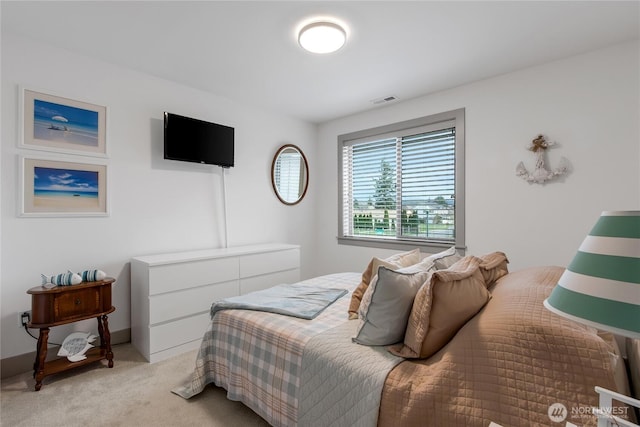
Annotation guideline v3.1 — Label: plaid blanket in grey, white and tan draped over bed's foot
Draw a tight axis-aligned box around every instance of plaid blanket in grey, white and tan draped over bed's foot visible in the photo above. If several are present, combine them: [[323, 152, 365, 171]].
[[172, 273, 362, 426]]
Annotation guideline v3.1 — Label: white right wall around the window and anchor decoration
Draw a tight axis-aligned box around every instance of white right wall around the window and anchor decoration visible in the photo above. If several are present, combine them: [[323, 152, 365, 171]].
[[315, 42, 640, 274]]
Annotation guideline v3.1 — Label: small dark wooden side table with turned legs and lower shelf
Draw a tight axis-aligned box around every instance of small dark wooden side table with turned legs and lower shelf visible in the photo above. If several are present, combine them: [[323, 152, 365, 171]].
[[27, 277, 115, 391]]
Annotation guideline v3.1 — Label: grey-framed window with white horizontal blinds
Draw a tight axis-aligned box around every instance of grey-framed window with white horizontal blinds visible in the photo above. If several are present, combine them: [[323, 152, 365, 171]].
[[338, 109, 464, 250]]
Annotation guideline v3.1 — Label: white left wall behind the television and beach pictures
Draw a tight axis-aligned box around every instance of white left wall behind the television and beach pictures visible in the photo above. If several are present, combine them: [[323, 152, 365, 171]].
[[0, 33, 316, 358]]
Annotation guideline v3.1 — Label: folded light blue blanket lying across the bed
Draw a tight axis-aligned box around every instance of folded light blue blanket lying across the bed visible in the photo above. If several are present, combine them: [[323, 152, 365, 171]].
[[211, 283, 347, 320]]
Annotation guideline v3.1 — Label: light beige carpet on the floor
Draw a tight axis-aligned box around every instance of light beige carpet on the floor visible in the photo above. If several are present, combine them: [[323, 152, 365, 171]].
[[0, 344, 268, 427]]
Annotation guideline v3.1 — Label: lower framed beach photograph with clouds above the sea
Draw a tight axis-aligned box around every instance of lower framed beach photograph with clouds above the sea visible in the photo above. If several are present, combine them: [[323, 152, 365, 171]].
[[20, 157, 109, 216]]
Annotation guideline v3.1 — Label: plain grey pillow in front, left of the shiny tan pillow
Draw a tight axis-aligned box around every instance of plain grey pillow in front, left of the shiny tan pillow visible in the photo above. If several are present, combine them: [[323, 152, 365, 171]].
[[353, 266, 431, 345]]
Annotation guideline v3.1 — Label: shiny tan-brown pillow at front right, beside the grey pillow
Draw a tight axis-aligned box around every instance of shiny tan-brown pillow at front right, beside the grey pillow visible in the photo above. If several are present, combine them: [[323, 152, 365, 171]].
[[389, 256, 490, 358]]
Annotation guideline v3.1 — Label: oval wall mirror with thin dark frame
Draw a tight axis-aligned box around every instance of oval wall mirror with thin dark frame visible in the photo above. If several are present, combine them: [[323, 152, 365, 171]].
[[271, 144, 309, 205]]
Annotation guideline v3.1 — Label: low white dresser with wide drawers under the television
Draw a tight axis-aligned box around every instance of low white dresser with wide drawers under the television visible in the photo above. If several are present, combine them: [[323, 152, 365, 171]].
[[131, 244, 300, 363]]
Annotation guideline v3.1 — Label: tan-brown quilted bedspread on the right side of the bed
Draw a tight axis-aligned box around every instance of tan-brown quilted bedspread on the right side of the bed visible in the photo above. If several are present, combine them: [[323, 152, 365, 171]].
[[378, 267, 615, 427]]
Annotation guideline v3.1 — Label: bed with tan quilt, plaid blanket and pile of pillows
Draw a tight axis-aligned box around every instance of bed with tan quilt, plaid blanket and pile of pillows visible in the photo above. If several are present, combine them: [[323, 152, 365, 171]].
[[172, 249, 628, 427]]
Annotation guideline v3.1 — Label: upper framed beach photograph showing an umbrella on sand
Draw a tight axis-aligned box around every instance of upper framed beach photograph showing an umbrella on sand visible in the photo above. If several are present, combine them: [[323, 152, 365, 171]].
[[20, 88, 107, 157]]
